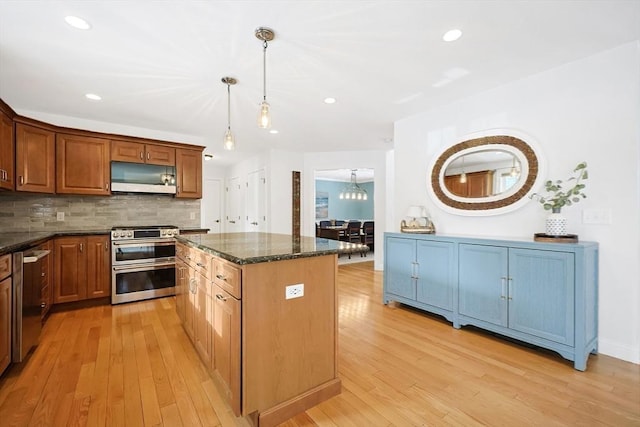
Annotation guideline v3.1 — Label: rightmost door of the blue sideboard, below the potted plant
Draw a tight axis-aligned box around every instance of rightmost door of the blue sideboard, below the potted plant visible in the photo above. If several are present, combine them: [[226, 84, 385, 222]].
[[509, 248, 575, 345]]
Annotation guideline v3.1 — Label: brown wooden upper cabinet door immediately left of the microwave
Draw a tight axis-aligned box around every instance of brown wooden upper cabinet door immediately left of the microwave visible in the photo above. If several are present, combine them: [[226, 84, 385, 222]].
[[56, 134, 111, 196]]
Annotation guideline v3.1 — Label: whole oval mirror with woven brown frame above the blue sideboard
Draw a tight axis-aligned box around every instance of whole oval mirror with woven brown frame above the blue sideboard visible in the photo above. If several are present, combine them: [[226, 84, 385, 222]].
[[430, 135, 540, 215]]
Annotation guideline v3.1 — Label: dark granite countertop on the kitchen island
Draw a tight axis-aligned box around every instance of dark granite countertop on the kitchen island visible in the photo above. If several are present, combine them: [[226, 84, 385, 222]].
[[176, 233, 344, 265]]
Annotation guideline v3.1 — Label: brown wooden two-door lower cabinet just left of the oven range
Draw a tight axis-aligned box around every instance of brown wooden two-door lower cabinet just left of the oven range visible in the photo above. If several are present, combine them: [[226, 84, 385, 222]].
[[53, 235, 111, 304]]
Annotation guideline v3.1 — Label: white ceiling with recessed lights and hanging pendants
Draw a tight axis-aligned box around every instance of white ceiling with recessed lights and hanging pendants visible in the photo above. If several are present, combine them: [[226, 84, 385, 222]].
[[0, 0, 640, 164]]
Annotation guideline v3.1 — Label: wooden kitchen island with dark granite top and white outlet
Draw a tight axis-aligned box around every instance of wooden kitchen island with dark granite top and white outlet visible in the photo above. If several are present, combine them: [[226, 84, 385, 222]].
[[176, 233, 341, 427]]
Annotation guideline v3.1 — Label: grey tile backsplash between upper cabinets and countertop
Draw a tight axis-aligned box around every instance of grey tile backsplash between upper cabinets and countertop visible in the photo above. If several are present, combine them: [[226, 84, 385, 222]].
[[0, 193, 200, 233]]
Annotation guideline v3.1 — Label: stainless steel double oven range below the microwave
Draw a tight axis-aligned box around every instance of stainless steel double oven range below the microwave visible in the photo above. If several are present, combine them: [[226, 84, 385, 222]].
[[111, 225, 180, 304]]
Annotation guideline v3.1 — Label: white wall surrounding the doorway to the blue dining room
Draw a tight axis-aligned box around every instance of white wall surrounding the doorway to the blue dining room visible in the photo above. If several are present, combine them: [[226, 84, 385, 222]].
[[301, 151, 389, 270]]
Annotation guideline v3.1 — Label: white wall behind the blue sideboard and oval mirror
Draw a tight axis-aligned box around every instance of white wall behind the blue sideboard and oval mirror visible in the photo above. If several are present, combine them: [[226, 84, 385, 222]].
[[387, 41, 640, 363]]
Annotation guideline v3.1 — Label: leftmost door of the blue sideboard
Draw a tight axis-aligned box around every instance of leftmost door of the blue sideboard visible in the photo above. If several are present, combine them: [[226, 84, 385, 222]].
[[384, 237, 416, 304]]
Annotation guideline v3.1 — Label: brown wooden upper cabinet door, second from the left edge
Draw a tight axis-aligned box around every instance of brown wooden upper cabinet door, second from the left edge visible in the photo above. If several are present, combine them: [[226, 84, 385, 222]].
[[15, 123, 56, 193]]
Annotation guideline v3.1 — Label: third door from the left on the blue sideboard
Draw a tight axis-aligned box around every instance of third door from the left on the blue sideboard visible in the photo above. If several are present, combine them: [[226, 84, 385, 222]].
[[458, 244, 509, 327]]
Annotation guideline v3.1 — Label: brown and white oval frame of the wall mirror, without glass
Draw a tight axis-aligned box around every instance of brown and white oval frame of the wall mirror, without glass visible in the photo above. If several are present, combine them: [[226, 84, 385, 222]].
[[430, 135, 540, 215]]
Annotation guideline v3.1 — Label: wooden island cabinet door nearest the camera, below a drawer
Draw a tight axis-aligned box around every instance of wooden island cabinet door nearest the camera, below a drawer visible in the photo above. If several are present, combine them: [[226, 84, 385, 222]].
[[213, 285, 241, 416]]
